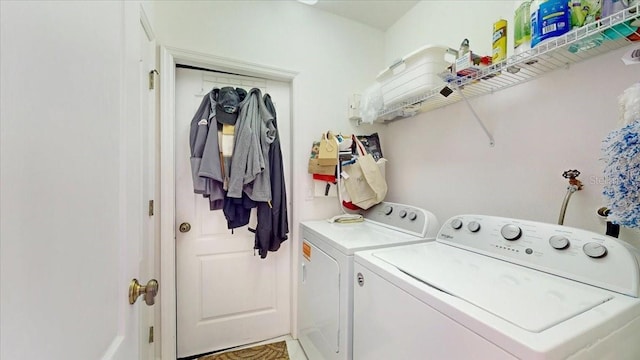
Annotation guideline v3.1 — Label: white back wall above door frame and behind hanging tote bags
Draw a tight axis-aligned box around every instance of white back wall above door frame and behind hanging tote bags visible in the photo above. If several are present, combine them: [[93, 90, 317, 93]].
[[152, 1, 384, 222]]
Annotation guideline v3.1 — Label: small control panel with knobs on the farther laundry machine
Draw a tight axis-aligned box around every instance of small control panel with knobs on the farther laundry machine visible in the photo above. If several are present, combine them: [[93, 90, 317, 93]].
[[362, 202, 440, 238]]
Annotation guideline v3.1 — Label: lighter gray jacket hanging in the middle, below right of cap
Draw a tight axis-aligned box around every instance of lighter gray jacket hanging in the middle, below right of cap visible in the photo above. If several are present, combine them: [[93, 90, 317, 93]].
[[227, 88, 277, 201]]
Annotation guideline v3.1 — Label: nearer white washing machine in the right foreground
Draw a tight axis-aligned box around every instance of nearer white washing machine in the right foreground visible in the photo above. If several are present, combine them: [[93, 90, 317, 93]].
[[353, 215, 640, 360]]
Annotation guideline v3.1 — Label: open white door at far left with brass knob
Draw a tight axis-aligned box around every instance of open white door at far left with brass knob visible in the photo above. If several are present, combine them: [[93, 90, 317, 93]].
[[0, 1, 147, 359]]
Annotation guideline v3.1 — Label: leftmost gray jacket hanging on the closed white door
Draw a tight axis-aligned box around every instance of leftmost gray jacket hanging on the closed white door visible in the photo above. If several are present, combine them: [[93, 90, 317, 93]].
[[189, 89, 224, 210]]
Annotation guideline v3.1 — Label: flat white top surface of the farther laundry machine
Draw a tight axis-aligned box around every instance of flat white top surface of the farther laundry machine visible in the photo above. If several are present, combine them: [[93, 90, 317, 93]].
[[302, 220, 433, 255]]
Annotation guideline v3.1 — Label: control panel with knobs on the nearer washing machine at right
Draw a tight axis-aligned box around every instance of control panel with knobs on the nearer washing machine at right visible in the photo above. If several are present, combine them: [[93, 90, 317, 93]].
[[437, 215, 640, 297]]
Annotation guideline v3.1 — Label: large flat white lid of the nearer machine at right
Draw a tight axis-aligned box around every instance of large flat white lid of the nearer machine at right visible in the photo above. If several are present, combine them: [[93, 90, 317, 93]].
[[373, 242, 613, 332]]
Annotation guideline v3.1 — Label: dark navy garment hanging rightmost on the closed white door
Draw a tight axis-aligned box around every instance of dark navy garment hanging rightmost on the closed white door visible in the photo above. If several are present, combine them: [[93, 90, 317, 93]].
[[254, 94, 289, 259]]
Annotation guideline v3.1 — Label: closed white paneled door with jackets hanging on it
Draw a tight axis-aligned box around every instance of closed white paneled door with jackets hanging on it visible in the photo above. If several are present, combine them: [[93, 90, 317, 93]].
[[175, 69, 291, 357]]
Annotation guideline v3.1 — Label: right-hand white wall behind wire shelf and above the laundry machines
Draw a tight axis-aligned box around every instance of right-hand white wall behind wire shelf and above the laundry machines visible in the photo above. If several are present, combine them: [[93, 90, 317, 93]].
[[382, 1, 640, 245]]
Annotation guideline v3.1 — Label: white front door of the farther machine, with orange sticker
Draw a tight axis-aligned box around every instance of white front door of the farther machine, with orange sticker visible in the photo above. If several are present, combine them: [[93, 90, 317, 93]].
[[298, 240, 340, 359]]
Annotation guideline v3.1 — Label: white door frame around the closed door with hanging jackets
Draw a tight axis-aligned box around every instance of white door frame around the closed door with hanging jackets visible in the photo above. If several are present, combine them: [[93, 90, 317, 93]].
[[159, 47, 298, 359]]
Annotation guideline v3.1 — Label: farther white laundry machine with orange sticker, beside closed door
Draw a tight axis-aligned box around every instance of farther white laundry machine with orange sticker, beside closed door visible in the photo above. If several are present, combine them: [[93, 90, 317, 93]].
[[298, 202, 439, 360]]
